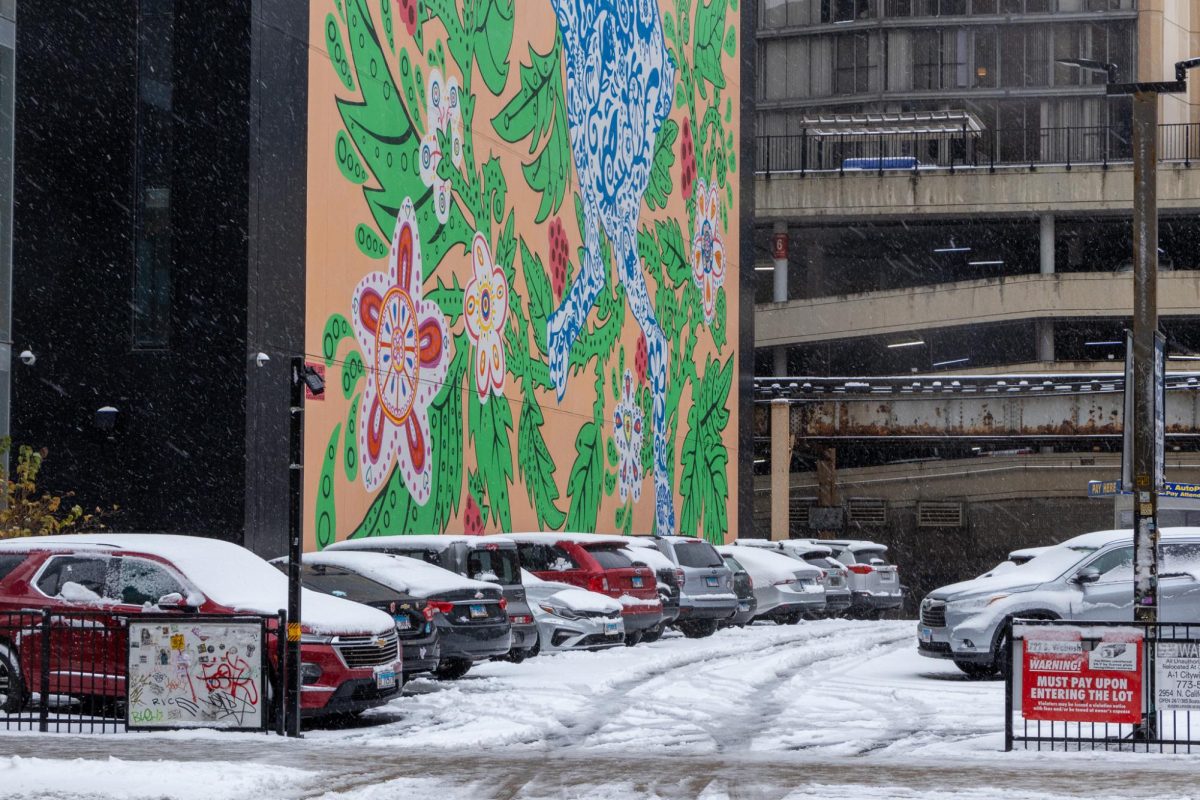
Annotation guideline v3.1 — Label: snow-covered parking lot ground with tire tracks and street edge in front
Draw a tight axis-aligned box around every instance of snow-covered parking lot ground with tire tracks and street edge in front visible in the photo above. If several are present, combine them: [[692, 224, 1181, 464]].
[[0, 621, 1200, 800]]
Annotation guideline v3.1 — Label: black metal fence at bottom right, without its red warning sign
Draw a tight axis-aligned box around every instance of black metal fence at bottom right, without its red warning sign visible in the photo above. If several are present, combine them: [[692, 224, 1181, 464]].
[[1004, 619, 1200, 753]]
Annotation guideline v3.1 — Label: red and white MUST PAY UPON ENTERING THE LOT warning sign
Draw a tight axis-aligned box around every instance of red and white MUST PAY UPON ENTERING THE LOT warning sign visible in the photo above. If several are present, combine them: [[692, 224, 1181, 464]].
[[1021, 627, 1142, 723]]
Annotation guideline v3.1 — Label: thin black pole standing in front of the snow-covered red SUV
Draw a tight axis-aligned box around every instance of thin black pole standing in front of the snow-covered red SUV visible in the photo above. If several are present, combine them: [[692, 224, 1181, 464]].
[[284, 356, 305, 736]]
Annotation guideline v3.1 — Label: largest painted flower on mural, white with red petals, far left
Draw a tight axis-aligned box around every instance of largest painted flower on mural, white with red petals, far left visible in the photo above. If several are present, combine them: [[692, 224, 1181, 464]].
[[352, 198, 450, 505]]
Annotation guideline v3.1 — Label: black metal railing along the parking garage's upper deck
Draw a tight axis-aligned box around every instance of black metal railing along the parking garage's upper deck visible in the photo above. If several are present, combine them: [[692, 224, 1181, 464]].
[[757, 122, 1200, 176]]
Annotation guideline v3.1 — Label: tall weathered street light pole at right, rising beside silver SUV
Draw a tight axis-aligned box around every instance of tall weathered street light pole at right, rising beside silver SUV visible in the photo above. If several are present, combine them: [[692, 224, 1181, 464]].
[[1133, 91, 1158, 624]]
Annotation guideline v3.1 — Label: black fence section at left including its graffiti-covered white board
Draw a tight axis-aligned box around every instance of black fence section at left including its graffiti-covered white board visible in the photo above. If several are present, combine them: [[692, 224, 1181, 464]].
[[0, 609, 287, 735]]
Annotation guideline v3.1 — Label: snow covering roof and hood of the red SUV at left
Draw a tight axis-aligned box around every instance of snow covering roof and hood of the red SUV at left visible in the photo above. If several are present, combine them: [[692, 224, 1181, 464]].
[[0, 534, 395, 633]]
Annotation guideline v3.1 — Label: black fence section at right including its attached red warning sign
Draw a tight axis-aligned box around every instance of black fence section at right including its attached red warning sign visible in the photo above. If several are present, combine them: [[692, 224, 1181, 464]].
[[1002, 619, 1200, 753]]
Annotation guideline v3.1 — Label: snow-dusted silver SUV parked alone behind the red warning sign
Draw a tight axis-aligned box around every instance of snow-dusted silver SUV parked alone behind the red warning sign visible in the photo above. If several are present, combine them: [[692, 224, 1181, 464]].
[[917, 528, 1200, 678]]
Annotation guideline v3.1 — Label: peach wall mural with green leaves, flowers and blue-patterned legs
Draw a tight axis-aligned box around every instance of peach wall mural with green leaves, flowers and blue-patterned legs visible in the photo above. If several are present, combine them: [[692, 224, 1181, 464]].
[[305, 0, 740, 548]]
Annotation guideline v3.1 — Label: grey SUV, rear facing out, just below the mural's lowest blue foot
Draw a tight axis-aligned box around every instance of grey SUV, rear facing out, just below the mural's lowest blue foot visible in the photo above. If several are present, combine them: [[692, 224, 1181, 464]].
[[652, 536, 738, 638]]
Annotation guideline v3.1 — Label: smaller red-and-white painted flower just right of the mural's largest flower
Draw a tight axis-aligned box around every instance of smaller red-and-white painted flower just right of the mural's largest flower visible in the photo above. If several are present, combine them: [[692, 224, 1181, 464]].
[[462, 233, 509, 403]]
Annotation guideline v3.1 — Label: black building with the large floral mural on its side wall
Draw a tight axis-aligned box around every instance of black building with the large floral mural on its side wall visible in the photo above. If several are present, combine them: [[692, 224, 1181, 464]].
[[12, 0, 754, 552]]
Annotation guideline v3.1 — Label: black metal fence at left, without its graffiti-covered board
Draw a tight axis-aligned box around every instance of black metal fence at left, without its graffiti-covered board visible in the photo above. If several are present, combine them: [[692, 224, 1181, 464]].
[[0, 609, 287, 734]]
